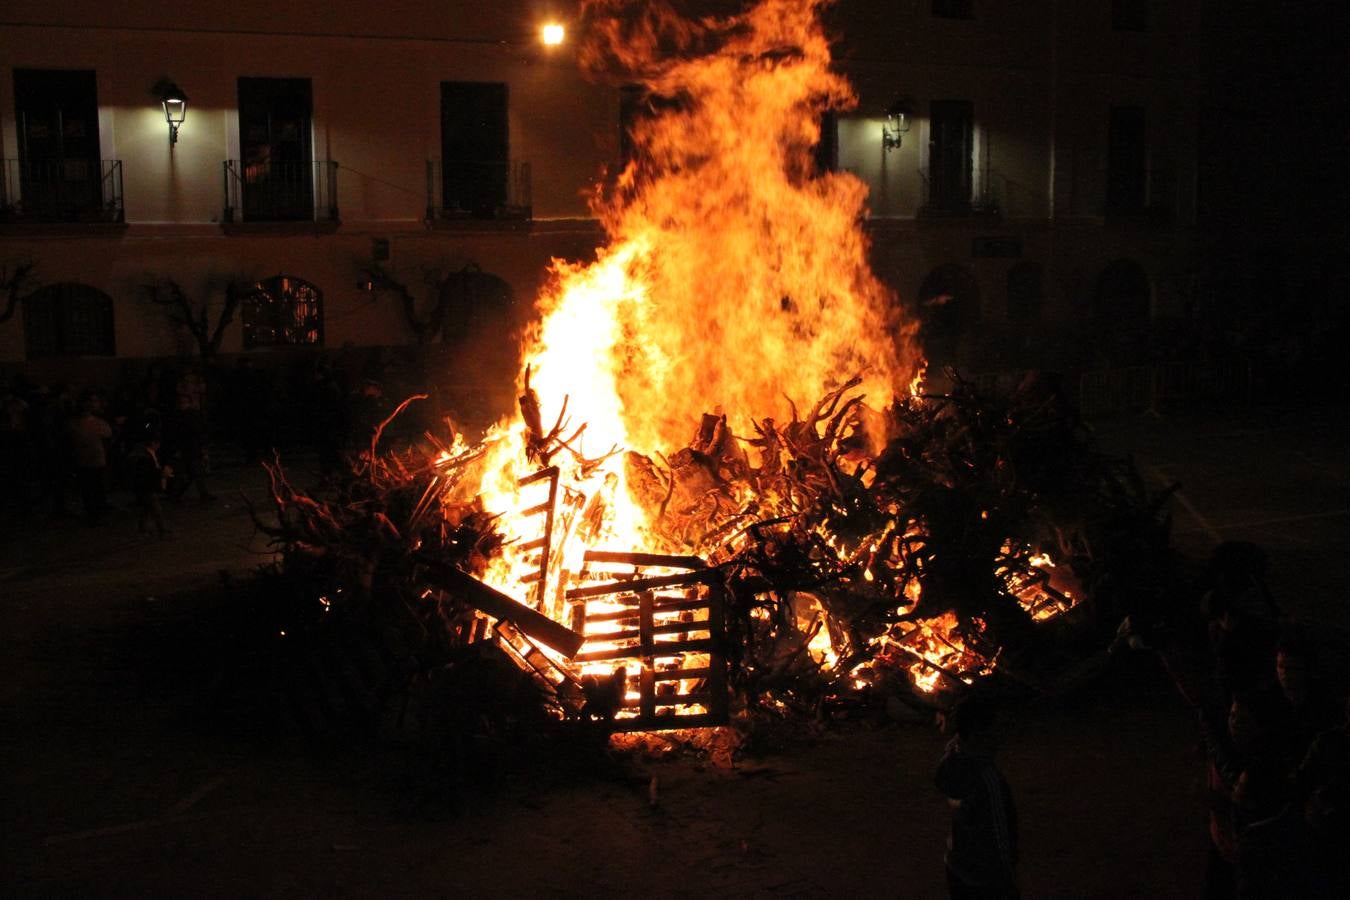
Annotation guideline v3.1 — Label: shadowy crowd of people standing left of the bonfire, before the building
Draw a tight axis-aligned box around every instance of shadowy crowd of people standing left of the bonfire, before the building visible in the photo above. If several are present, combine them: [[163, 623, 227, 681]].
[[0, 356, 402, 536]]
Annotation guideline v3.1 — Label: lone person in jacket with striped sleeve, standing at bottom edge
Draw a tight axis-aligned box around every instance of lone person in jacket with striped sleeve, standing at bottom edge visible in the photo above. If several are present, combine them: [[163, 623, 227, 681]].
[[934, 698, 1018, 900]]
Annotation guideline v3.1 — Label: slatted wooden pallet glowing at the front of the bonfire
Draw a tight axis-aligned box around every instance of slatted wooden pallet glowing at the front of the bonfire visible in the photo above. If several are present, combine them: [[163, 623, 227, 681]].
[[566, 551, 728, 731]]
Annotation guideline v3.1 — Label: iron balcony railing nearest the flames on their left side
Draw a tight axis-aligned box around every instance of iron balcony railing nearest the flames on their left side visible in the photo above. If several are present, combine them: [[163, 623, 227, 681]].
[[427, 159, 532, 221]]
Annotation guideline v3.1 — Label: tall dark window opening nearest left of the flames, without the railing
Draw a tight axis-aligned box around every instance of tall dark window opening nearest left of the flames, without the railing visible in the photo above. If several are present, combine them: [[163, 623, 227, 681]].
[[440, 81, 510, 217]]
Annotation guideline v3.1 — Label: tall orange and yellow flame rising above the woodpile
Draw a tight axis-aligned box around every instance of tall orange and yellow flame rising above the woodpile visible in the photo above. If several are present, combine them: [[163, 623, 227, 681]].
[[525, 0, 918, 453]]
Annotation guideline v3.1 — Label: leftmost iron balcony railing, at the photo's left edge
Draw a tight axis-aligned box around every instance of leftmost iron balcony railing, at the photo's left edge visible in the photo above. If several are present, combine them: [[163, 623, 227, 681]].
[[0, 159, 124, 223]]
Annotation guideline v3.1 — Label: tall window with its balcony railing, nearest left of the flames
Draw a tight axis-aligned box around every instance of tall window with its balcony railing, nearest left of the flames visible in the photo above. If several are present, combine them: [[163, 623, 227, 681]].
[[427, 81, 531, 220]]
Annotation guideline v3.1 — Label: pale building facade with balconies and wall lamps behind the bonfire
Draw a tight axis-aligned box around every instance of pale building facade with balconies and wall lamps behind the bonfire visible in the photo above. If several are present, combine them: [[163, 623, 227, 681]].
[[0, 0, 1200, 376]]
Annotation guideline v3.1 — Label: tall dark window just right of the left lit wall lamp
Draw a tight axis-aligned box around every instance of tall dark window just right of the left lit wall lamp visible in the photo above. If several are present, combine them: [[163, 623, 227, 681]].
[[239, 78, 315, 221]]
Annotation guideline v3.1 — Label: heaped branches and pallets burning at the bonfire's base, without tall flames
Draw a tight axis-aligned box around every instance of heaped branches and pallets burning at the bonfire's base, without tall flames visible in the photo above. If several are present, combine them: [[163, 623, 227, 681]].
[[248, 367, 1168, 731]]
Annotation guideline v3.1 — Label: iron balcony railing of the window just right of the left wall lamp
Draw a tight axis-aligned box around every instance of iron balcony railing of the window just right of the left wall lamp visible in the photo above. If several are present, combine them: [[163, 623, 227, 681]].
[[224, 159, 338, 224]]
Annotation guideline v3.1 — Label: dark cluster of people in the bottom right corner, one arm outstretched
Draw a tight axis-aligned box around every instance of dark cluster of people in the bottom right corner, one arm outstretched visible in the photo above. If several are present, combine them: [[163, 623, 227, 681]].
[[1131, 541, 1350, 897]]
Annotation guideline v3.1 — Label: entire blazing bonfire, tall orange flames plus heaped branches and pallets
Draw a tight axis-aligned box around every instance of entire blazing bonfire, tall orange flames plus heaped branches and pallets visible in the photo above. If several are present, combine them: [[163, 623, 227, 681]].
[[234, 0, 1182, 755]]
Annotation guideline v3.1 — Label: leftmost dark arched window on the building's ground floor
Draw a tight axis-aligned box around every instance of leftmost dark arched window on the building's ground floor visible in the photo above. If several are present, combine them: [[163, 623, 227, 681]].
[[23, 282, 117, 359]]
